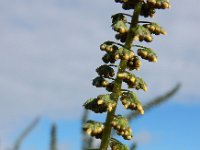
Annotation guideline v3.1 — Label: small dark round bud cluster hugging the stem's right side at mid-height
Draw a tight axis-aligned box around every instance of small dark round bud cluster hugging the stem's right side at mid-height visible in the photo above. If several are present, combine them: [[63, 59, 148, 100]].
[[127, 56, 142, 70]]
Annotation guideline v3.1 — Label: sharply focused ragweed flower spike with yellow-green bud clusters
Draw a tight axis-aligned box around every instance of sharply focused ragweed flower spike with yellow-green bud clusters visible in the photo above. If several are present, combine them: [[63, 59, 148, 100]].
[[83, 0, 170, 150]]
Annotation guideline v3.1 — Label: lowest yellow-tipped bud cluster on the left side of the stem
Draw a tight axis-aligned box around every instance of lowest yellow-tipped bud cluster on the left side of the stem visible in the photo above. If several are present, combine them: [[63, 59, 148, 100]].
[[83, 120, 104, 139]]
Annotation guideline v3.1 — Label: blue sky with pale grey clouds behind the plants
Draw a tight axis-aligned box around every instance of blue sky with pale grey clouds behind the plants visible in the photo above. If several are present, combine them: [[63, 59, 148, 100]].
[[0, 0, 200, 150]]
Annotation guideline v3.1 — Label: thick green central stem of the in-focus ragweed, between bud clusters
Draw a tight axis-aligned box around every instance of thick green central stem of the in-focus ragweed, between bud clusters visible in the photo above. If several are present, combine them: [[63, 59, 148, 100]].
[[100, 2, 142, 150]]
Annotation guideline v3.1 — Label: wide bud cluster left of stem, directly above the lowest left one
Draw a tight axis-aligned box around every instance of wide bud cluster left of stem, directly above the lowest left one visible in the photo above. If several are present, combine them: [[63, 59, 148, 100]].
[[83, 94, 116, 113]]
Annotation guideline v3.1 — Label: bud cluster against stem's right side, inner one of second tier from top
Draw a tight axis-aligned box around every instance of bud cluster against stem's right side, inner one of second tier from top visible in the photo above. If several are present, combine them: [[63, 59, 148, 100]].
[[132, 25, 153, 42]]
